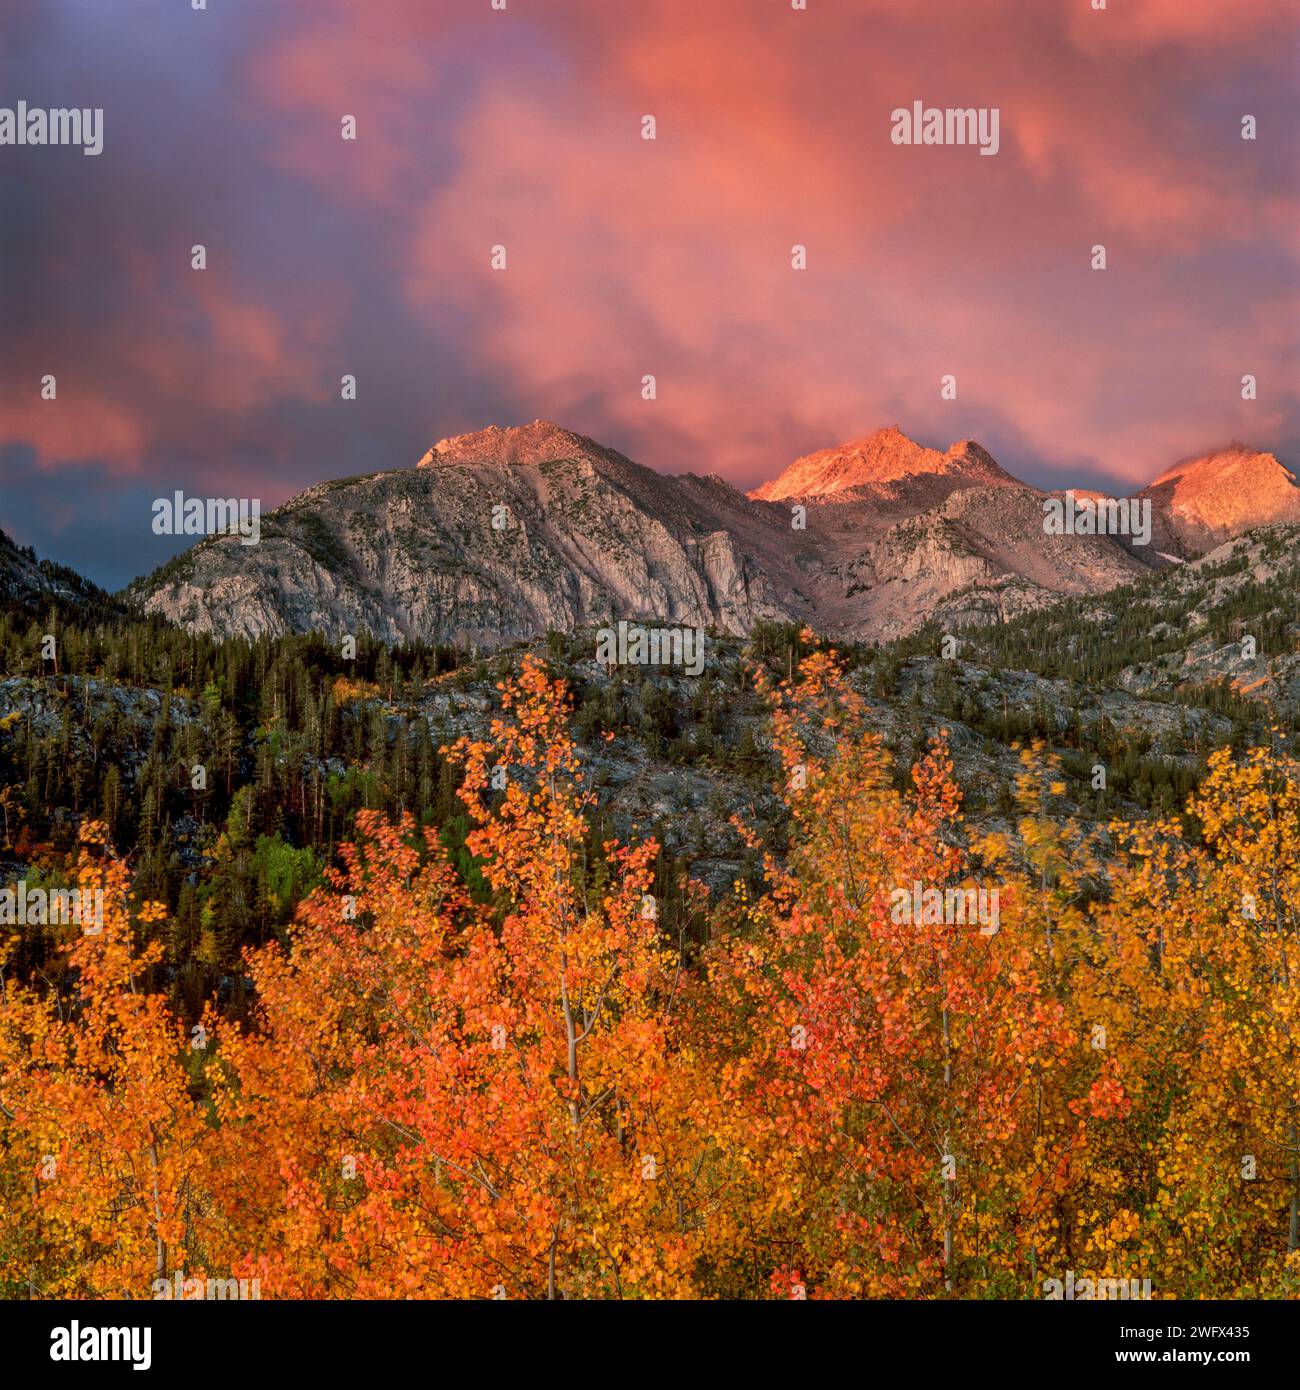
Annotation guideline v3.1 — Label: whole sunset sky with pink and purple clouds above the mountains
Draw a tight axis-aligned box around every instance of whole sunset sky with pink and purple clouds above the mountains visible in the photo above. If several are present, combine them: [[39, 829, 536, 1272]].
[[0, 0, 1300, 588]]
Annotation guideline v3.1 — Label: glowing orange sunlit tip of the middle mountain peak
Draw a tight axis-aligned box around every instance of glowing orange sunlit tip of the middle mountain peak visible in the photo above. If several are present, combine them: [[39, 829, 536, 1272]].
[[749, 425, 1015, 502]]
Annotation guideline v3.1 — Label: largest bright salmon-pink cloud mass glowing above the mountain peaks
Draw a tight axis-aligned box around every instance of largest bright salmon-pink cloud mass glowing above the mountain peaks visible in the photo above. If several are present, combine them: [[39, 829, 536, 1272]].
[[375, 3, 1296, 481]]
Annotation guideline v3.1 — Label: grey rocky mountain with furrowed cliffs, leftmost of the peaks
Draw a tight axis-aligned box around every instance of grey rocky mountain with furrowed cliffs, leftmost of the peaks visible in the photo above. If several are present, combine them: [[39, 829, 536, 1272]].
[[131, 425, 793, 645]]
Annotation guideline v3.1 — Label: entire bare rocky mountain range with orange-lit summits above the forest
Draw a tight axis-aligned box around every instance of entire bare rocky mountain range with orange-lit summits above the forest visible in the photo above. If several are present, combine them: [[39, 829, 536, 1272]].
[[128, 421, 1300, 646]]
